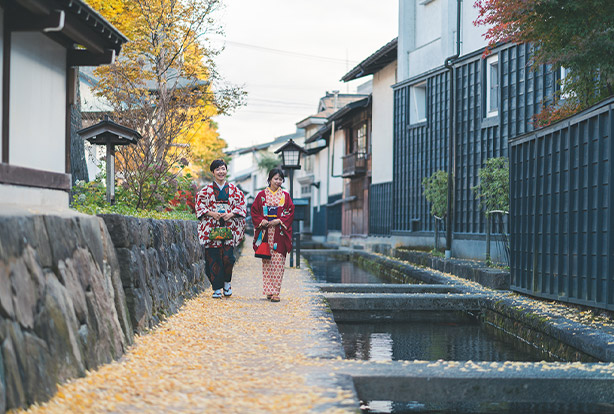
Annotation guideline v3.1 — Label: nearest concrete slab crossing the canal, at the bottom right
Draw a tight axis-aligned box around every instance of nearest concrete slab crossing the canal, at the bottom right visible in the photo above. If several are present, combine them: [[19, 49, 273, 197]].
[[336, 361, 614, 412]]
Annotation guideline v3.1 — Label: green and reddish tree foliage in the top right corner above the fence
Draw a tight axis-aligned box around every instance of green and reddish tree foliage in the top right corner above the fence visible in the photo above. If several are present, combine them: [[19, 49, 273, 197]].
[[474, 0, 614, 125]]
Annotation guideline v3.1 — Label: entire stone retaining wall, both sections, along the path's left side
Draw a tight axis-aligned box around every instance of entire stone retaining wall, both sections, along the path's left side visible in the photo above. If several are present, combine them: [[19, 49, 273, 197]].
[[0, 212, 208, 413]]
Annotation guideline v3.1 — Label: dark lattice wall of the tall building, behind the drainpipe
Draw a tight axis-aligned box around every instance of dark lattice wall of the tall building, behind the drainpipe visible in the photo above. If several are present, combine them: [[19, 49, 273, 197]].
[[391, 45, 557, 236]]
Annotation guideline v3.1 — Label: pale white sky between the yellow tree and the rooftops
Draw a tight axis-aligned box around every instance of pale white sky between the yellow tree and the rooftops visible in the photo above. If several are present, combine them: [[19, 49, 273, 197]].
[[212, 0, 398, 149]]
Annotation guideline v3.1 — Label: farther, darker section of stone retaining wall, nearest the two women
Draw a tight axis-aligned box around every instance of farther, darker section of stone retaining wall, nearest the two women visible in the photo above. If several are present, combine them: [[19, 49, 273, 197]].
[[100, 214, 210, 333]]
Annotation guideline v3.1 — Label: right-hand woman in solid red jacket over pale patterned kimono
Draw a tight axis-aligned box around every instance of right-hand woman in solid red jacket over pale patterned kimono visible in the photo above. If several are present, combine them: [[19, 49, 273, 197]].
[[251, 168, 294, 302]]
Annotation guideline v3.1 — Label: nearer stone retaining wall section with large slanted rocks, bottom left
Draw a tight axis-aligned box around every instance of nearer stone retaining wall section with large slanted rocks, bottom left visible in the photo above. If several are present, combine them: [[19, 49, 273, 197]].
[[0, 215, 132, 412]]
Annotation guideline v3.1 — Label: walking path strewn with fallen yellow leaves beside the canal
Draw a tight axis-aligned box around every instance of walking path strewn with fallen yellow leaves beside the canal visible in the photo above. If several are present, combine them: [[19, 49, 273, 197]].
[[22, 240, 358, 413]]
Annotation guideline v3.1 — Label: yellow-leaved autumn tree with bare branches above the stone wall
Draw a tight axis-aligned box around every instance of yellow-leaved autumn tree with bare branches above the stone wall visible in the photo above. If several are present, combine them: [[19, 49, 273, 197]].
[[89, 0, 244, 208]]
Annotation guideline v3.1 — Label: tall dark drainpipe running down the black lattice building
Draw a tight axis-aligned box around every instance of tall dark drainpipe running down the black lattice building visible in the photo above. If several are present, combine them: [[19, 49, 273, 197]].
[[444, 0, 462, 259]]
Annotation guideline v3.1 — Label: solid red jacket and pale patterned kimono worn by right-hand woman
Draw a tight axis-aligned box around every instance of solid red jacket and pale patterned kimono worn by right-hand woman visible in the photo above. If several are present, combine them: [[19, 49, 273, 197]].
[[251, 187, 294, 296]]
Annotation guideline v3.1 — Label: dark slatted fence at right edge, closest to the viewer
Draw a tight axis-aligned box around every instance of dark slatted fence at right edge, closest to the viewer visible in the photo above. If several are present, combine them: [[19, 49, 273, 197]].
[[510, 99, 614, 309]]
